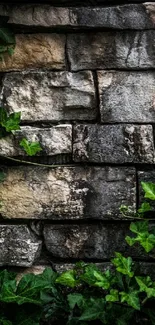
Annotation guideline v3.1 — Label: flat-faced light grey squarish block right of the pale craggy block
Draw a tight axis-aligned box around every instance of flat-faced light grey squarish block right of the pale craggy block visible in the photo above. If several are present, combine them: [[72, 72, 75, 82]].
[[98, 71, 155, 123]]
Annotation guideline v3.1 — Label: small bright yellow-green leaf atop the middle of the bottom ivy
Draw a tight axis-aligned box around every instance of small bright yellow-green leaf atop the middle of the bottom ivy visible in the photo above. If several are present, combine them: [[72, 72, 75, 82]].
[[56, 270, 78, 288]]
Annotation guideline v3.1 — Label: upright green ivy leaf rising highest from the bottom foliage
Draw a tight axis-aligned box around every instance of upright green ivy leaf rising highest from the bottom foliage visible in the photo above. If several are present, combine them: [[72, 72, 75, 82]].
[[112, 253, 134, 278]]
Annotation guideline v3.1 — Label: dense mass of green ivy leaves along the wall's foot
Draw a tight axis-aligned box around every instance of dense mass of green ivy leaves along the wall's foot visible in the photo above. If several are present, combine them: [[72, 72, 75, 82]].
[[0, 248, 155, 325]]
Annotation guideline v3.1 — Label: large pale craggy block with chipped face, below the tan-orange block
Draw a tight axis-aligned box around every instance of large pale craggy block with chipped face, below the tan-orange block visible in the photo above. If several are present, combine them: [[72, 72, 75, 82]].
[[3, 71, 97, 121]]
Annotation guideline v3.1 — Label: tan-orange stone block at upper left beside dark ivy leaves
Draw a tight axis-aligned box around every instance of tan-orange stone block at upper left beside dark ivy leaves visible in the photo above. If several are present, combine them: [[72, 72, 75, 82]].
[[0, 33, 65, 71]]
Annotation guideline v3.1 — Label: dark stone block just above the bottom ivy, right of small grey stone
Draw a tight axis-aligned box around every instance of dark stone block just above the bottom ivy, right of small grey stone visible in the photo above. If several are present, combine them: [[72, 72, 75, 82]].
[[44, 223, 154, 260]]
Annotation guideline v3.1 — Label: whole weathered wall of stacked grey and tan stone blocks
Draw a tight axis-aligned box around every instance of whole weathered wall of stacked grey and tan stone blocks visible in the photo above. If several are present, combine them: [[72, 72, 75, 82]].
[[0, 0, 155, 271]]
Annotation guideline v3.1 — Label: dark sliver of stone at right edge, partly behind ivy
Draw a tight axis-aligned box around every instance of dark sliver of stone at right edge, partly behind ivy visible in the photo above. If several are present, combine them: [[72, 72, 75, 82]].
[[138, 168, 155, 210]]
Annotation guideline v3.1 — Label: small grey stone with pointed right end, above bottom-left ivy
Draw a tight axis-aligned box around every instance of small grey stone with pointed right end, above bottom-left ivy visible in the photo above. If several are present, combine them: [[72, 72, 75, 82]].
[[0, 224, 42, 267]]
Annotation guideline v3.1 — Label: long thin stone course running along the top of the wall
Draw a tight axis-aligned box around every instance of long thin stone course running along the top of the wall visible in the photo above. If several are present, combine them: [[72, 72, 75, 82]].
[[0, 3, 155, 29]]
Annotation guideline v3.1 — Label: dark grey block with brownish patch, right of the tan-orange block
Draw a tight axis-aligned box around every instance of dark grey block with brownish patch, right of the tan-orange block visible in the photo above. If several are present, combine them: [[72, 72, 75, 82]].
[[67, 30, 155, 71]]
